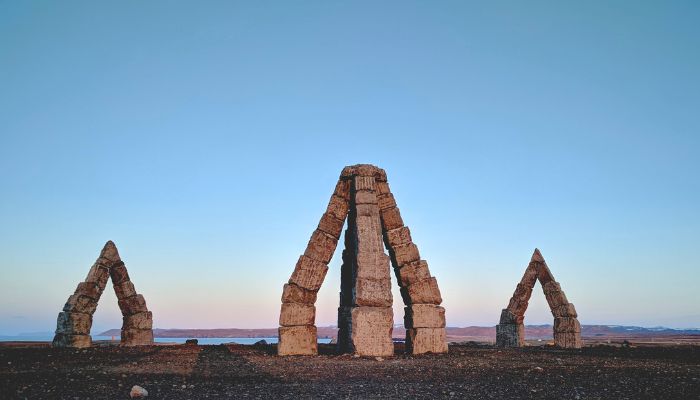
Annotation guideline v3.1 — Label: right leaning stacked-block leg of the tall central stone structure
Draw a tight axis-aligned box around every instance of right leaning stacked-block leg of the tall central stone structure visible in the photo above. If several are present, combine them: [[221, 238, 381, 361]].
[[377, 181, 447, 354]]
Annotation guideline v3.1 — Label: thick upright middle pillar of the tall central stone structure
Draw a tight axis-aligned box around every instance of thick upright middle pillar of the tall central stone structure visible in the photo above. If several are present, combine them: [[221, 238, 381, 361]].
[[338, 174, 394, 356]]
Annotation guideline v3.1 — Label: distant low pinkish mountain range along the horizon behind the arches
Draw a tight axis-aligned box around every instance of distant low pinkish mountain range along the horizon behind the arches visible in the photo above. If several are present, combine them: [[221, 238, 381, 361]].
[[99, 325, 700, 341]]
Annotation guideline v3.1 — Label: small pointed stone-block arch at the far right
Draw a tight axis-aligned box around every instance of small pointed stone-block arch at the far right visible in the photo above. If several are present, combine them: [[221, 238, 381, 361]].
[[496, 249, 582, 348]]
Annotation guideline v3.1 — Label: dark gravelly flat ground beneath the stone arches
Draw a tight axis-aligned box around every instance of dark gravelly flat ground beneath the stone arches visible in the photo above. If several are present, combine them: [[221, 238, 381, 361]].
[[0, 344, 700, 399]]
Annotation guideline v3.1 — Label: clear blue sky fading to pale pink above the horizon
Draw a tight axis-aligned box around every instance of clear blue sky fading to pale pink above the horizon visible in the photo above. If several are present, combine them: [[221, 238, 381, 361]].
[[0, 1, 700, 334]]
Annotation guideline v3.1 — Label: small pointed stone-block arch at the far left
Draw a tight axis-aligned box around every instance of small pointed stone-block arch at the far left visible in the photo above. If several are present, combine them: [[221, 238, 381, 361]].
[[53, 240, 153, 347]]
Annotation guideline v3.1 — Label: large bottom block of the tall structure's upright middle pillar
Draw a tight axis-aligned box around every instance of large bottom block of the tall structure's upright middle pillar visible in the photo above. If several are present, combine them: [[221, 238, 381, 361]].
[[351, 307, 394, 357]]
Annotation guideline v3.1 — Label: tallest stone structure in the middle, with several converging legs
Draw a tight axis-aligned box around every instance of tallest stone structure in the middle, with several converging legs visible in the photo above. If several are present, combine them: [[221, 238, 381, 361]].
[[278, 164, 447, 356]]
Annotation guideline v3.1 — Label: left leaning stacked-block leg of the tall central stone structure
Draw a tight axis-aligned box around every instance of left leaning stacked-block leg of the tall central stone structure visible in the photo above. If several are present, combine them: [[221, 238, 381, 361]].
[[277, 179, 350, 355]]
